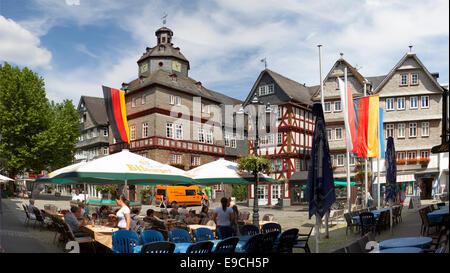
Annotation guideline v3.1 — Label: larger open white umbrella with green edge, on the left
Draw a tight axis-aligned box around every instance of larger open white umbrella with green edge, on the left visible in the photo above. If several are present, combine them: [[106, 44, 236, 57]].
[[51, 150, 194, 185]]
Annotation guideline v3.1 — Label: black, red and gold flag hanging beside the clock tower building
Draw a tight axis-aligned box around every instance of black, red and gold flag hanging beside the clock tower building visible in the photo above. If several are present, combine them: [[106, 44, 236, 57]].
[[102, 86, 130, 143]]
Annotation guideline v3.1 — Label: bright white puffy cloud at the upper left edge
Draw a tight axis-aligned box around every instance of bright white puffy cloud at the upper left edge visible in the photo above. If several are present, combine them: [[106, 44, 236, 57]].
[[0, 16, 52, 68]]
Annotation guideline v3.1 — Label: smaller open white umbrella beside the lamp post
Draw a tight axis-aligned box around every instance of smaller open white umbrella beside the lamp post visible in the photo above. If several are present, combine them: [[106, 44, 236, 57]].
[[186, 158, 277, 185]]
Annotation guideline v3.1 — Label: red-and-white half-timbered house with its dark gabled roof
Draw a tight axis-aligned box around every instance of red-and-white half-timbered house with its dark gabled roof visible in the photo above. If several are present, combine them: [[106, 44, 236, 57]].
[[244, 69, 317, 205]]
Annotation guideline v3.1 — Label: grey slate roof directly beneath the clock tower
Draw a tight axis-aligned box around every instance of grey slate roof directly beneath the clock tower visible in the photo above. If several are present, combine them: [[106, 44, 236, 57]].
[[124, 69, 242, 104]]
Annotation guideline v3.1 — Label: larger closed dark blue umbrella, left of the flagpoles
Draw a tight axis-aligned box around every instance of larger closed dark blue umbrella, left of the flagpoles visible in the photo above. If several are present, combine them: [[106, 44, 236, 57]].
[[306, 103, 336, 218]]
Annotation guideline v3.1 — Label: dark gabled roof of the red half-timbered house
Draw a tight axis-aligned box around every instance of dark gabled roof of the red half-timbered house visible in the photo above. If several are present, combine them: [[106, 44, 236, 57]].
[[245, 68, 314, 105]]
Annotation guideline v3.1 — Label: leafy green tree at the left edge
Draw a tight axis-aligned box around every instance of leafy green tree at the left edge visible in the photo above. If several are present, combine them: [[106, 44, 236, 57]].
[[0, 63, 81, 177]]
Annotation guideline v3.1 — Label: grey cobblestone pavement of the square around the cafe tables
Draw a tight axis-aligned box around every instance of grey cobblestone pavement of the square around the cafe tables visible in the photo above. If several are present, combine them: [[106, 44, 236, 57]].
[[0, 196, 446, 253]]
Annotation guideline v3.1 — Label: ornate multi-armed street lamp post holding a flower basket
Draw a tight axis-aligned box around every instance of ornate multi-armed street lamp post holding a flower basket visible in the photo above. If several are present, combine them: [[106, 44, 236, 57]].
[[238, 94, 272, 224]]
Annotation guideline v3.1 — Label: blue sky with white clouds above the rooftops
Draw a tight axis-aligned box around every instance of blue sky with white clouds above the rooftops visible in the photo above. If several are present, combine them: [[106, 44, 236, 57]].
[[0, 0, 449, 105]]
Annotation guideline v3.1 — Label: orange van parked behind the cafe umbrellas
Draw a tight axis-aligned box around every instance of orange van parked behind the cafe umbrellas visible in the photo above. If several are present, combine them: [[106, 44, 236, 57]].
[[155, 185, 208, 207]]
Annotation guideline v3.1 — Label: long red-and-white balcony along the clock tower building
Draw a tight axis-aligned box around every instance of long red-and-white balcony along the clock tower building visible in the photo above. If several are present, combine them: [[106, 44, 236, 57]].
[[109, 136, 225, 156]]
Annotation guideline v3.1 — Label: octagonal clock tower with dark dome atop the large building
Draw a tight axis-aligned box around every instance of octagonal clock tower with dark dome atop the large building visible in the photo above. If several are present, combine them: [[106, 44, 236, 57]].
[[137, 26, 189, 77]]
